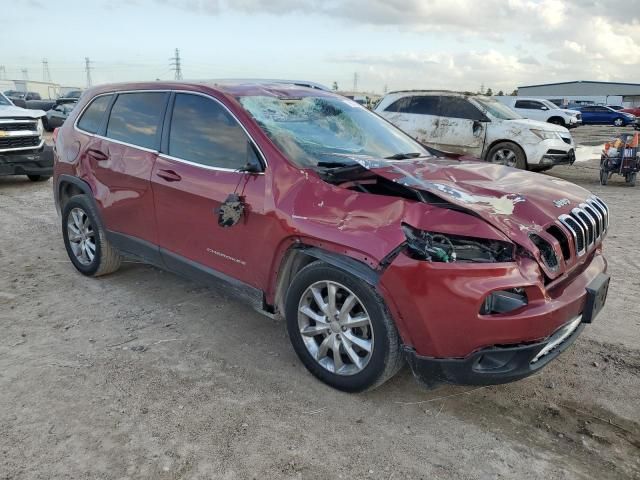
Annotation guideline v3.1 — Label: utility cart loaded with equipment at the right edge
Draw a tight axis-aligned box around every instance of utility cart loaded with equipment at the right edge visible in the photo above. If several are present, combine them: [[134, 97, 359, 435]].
[[600, 133, 640, 187]]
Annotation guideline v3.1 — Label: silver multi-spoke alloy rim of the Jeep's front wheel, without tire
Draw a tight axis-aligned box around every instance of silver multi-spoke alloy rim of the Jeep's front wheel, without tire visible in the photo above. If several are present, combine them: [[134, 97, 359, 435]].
[[298, 281, 374, 375]]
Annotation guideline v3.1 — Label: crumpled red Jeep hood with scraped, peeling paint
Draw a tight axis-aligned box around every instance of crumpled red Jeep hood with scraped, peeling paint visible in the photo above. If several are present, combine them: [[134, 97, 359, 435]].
[[354, 157, 591, 249]]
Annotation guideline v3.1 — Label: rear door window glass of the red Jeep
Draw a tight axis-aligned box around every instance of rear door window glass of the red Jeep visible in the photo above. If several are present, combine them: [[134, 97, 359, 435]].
[[107, 92, 167, 148]]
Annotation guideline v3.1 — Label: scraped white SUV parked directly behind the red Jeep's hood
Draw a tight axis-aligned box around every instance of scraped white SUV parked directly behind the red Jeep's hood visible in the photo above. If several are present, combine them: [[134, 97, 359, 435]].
[[375, 91, 575, 171]]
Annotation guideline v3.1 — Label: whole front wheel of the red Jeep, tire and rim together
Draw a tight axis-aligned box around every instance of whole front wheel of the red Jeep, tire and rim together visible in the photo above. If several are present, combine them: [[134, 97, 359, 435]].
[[285, 262, 404, 392]]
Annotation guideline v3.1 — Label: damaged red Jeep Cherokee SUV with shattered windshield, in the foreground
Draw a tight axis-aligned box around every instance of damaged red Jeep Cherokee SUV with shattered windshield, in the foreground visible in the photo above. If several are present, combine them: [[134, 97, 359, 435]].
[[54, 82, 609, 391]]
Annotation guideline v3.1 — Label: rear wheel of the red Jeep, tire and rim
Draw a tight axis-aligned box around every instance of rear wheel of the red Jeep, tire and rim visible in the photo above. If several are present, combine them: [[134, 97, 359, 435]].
[[62, 195, 121, 277]]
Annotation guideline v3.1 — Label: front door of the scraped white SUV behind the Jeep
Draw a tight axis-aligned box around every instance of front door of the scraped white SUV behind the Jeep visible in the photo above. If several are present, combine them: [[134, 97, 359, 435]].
[[436, 96, 487, 158]]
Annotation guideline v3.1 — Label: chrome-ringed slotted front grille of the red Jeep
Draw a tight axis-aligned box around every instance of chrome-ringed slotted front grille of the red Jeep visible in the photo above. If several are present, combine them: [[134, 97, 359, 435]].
[[547, 195, 609, 259]]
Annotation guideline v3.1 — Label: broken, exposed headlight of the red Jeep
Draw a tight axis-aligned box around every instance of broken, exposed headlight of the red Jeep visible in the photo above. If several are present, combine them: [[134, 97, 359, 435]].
[[402, 223, 514, 263]]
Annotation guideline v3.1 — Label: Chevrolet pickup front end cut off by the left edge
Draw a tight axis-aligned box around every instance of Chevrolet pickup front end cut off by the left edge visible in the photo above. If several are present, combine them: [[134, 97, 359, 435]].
[[0, 93, 53, 182]]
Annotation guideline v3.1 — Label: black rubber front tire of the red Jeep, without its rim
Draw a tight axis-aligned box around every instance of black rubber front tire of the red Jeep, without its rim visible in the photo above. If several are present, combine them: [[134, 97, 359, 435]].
[[285, 262, 390, 392]]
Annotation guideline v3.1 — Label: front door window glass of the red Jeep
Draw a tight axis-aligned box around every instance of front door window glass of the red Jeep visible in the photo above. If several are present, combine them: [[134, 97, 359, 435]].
[[169, 93, 248, 170]]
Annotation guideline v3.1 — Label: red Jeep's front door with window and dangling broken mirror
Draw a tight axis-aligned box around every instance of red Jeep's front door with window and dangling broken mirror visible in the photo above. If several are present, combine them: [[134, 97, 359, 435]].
[[151, 93, 271, 289]]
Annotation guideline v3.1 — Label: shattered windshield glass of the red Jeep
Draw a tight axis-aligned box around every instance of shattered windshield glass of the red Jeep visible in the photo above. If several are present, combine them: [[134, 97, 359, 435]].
[[238, 95, 431, 168]]
